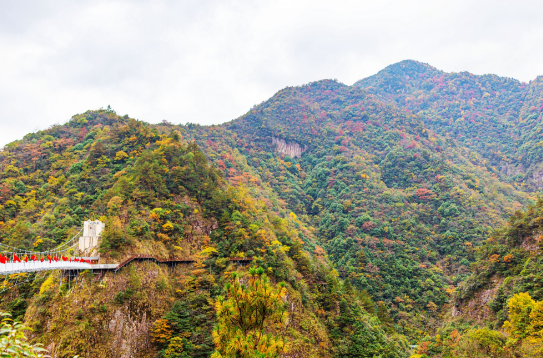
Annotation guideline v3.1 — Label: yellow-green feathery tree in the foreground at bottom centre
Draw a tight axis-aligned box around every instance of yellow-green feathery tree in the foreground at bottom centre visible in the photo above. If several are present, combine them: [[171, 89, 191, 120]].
[[212, 268, 288, 358]]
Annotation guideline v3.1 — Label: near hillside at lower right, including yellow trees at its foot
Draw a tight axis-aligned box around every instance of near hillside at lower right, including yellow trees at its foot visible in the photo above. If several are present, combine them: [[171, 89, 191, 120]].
[[412, 199, 543, 358]]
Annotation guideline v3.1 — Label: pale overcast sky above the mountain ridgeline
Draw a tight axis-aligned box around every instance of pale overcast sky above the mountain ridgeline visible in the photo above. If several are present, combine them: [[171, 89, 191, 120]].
[[0, 0, 543, 146]]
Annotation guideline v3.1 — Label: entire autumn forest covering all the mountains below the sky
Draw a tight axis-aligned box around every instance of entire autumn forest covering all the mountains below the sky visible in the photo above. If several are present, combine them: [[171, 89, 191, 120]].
[[0, 61, 543, 357]]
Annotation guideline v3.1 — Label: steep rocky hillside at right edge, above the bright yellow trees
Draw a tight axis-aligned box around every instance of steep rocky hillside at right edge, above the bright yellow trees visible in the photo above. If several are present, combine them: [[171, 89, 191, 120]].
[[456, 199, 543, 327]]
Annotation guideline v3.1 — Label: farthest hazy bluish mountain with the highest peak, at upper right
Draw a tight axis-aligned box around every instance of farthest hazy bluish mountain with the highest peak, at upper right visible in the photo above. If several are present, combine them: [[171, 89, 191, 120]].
[[355, 60, 543, 188]]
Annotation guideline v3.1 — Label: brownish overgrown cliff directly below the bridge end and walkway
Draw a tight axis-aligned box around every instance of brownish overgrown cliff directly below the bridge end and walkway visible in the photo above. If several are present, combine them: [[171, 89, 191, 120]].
[[27, 262, 176, 358]]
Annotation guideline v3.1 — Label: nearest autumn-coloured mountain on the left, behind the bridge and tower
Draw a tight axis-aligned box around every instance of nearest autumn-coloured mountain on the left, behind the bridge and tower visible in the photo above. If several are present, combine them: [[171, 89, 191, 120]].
[[0, 110, 409, 358]]
